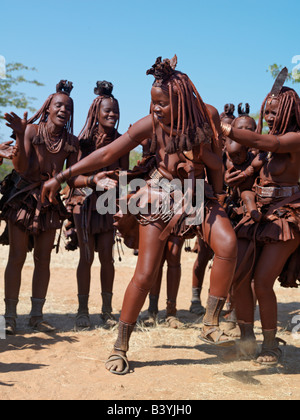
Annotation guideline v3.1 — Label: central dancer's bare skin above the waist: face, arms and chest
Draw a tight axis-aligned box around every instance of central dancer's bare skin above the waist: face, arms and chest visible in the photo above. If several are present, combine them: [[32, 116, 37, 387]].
[[43, 87, 223, 202]]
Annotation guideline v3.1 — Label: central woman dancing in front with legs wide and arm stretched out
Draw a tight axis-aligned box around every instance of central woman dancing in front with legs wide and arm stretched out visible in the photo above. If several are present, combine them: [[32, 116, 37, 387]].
[[43, 57, 237, 374]]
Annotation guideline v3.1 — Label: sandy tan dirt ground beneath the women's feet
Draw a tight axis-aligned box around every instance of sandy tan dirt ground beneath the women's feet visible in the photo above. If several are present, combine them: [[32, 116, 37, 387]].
[[0, 235, 300, 401]]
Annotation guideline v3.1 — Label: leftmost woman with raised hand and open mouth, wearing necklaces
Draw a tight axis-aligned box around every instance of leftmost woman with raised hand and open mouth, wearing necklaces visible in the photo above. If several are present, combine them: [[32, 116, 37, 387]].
[[0, 81, 78, 334]]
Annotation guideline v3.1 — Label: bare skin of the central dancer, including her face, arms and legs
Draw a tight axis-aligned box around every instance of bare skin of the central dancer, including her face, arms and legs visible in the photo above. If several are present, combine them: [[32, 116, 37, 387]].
[[43, 83, 237, 372]]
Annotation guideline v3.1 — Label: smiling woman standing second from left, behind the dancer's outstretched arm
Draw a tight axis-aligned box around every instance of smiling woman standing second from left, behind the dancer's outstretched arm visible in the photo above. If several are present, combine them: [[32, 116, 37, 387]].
[[73, 81, 129, 328]]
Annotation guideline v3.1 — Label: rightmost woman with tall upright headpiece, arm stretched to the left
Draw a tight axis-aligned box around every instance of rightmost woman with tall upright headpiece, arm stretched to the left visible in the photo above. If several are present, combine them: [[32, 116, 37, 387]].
[[223, 69, 300, 365]]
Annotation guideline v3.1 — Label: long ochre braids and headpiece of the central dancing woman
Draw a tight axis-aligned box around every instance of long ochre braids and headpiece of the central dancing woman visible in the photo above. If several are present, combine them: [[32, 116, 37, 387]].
[[146, 56, 218, 154]]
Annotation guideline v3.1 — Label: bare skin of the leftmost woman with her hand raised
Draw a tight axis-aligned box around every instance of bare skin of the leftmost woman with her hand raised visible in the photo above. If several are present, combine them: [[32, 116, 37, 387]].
[[4, 93, 77, 330]]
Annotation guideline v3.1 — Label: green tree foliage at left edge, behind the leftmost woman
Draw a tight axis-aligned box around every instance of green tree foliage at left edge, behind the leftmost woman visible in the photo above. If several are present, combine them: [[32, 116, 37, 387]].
[[0, 63, 44, 139]]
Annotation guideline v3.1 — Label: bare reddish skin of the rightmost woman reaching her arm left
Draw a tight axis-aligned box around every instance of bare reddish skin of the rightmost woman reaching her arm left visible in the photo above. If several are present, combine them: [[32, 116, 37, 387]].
[[229, 98, 300, 363]]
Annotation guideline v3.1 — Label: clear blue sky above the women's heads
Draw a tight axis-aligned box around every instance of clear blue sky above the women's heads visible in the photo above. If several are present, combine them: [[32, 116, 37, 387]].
[[0, 0, 300, 141]]
